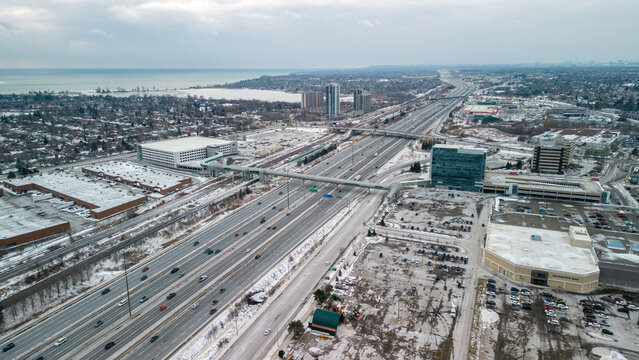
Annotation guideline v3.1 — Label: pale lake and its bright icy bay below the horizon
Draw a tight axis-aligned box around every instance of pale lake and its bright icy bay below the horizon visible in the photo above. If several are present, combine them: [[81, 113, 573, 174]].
[[0, 69, 300, 102]]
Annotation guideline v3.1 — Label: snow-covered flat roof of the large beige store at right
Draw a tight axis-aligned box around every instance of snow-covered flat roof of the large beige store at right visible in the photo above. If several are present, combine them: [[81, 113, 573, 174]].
[[486, 223, 599, 275]]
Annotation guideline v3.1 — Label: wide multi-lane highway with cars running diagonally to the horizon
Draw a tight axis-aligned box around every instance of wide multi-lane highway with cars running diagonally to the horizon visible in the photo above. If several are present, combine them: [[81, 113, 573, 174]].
[[0, 79, 466, 359]]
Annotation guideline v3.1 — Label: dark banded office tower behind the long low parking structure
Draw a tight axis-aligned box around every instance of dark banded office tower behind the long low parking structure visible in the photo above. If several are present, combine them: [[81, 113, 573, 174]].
[[530, 141, 575, 174]]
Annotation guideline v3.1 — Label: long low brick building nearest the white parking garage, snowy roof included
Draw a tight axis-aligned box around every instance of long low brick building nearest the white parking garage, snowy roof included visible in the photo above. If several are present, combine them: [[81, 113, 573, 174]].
[[82, 161, 192, 195]]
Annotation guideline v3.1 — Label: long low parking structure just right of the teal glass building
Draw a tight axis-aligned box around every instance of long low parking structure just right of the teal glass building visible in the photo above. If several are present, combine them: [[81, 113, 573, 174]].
[[482, 172, 610, 203]]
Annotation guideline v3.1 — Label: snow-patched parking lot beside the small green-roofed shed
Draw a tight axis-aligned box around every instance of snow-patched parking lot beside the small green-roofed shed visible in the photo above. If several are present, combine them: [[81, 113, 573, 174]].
[[287, 236, 469, 359]]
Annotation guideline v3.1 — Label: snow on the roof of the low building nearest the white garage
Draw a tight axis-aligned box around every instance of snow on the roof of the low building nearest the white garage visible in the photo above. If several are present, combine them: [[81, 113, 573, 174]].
[[85, 161, 186, 189]]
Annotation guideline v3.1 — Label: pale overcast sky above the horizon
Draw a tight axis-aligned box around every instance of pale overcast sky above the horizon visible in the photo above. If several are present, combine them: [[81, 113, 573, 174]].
[[0, 0, 639, 68]]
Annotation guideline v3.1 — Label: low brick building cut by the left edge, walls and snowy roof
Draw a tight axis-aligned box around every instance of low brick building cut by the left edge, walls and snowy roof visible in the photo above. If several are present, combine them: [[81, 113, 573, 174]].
[[0, 199, 71, 247]]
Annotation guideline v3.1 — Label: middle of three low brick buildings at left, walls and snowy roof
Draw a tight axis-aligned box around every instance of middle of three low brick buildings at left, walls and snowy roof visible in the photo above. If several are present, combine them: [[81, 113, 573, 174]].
[[4, 172, 147, 219]]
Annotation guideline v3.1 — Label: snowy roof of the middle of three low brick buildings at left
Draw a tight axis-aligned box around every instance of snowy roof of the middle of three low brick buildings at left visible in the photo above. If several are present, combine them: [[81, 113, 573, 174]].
[[7, 172, 145, 212]]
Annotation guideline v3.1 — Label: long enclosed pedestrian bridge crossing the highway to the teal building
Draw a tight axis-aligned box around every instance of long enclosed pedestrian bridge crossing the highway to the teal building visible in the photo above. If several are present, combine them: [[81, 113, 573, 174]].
[[208, 162, 403, 200]]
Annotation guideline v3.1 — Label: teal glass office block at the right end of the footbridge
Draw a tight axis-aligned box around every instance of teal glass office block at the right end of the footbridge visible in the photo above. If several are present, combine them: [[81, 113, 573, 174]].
[[431, 144, 486, 191]]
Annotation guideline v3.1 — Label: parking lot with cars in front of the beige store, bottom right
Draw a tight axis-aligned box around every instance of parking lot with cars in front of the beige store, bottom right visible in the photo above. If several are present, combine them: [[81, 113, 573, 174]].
[[473, 278, 639, 359]]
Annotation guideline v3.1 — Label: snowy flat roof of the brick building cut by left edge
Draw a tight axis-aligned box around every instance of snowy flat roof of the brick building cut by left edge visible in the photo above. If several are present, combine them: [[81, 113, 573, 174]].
[[0, 199, 67, 239]]
